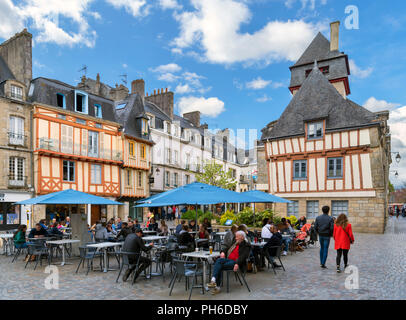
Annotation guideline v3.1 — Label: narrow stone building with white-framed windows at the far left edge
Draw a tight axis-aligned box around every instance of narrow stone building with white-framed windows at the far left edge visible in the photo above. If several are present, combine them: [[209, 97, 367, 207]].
[[0, 30, 34, 231]]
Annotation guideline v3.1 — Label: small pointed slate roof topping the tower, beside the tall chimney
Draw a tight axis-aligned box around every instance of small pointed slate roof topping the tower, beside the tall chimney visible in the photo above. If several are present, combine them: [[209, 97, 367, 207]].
[[291, 32, 345, 68]]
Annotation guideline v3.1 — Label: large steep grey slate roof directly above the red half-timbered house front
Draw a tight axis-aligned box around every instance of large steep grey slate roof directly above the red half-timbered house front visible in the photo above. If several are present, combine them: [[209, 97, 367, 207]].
[[261, 65, 379, 140]]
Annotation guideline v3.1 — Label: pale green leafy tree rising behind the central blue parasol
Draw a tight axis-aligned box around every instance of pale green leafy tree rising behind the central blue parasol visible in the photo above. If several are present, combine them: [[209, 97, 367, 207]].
[[196, 160, 237, 190]]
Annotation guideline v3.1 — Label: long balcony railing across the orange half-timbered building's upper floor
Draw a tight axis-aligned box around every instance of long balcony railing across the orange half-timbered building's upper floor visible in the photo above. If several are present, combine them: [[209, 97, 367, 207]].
[[39, 138, 123, 161]]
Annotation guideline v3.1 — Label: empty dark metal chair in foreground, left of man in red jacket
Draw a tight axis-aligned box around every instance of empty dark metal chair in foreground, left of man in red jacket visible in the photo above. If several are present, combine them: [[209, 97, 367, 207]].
[[169, 259, 204, 300]]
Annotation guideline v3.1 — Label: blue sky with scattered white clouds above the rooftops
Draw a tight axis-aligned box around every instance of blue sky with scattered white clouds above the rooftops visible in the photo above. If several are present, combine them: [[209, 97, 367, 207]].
[[0, 0, 406, 183]]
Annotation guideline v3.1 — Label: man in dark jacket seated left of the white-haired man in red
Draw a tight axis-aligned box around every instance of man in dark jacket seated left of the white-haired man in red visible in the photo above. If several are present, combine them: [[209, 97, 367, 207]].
[[122, 229, 154, 281]]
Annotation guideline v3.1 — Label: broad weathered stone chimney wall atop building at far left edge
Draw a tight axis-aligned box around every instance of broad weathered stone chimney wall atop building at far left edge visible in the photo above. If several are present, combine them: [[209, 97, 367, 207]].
[[0, 29, 32, 88]]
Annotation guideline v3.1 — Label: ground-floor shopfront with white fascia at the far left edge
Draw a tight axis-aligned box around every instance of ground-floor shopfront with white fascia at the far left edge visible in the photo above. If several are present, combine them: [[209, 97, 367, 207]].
[[0, 191, 31, 231]]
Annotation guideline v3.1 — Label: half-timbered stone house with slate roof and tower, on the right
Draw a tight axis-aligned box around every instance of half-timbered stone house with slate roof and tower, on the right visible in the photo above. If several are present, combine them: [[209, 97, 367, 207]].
[[262, 23, 391, 233]]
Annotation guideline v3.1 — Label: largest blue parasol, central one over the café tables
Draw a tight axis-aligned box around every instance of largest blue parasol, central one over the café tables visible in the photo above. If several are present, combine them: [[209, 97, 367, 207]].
[[135, 182, 258, 208]]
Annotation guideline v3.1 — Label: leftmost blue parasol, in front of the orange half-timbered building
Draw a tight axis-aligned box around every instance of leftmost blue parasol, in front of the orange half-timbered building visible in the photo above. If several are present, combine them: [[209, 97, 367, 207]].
[[15, 189, 122, 205]]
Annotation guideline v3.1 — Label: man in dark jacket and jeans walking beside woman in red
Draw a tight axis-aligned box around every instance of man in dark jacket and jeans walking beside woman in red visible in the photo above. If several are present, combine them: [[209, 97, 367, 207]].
[[314, 206, 334, 269]]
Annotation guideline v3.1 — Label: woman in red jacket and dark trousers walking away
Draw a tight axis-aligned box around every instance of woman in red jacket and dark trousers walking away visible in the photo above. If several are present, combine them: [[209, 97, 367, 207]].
[[333, 213, 354, 272]]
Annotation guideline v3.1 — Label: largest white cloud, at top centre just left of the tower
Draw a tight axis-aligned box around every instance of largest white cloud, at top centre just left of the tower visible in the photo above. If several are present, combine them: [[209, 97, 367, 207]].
[[172, 0, 317, 64]]
